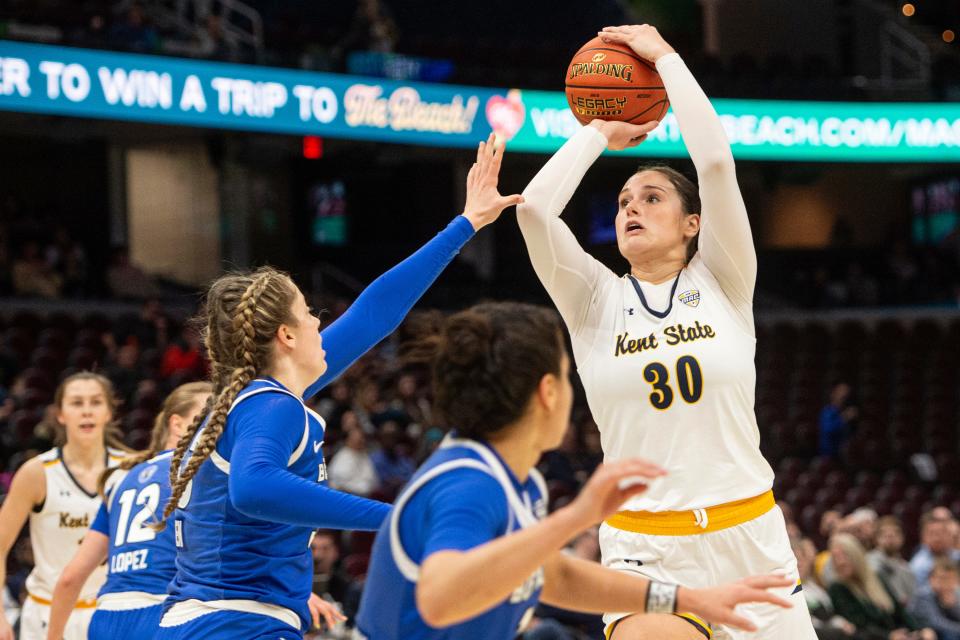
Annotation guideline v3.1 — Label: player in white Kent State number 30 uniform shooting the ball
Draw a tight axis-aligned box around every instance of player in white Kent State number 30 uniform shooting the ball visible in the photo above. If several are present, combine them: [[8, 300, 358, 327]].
[[517, 25, 815, 640]]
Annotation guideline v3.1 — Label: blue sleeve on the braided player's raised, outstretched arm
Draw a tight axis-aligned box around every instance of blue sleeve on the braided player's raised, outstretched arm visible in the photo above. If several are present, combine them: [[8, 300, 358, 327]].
[[303, 216, 474, 398]]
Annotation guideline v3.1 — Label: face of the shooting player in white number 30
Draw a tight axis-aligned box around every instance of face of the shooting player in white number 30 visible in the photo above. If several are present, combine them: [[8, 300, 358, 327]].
[[616, 171, 700, 265]]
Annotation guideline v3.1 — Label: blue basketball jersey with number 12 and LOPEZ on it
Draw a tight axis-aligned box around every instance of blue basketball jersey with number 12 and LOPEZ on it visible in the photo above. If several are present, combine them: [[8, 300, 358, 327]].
[[91, 451, 177, 597]]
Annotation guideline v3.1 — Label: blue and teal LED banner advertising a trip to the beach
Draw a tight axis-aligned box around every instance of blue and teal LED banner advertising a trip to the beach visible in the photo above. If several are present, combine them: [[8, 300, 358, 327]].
[[0, 40, 960, 162]]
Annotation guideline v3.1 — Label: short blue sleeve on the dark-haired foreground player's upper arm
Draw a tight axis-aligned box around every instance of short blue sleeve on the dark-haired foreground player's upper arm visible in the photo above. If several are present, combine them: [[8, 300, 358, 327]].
[[414, 469, 508, 562]]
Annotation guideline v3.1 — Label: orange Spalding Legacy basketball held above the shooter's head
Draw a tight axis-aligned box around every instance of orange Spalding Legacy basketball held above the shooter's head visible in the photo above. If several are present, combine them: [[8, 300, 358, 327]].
[[566, 37, 670, 124]]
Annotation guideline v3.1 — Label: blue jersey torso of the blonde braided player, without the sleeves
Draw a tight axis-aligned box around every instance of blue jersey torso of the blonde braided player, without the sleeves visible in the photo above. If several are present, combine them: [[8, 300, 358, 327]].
[[164, 379, 326, 630]]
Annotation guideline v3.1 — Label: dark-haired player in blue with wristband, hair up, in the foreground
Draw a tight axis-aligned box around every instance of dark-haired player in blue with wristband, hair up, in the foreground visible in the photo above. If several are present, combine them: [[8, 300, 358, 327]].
[[357, 303, 789, 640]]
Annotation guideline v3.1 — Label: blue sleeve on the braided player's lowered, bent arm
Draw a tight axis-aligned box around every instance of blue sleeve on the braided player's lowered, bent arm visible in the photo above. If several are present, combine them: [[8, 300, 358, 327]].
[[229, 393, 390, 531]]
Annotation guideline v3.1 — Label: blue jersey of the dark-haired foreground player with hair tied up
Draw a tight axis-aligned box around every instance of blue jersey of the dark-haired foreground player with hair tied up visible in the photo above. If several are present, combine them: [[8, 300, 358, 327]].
[[357, 437, 547, 640]]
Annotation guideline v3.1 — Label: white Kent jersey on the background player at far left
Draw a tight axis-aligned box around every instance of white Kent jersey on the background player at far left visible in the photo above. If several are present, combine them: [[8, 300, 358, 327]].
[[27, 448, 123, 600]]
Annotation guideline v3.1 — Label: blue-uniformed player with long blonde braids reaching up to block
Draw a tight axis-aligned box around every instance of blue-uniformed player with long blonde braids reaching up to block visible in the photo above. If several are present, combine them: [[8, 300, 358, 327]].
[[156, 137, 522, 640]]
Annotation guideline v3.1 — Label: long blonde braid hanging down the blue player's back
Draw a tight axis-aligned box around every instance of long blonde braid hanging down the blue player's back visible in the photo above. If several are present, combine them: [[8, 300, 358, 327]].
[[160, 271, 275, 527]]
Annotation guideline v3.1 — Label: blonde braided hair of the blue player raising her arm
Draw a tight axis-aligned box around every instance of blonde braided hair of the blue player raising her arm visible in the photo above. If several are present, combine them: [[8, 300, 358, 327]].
[[159, 267, 297, 528]]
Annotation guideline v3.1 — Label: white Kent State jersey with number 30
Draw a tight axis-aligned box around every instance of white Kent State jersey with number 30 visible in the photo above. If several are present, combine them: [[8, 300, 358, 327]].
[[573, 255, 773, 511]]
